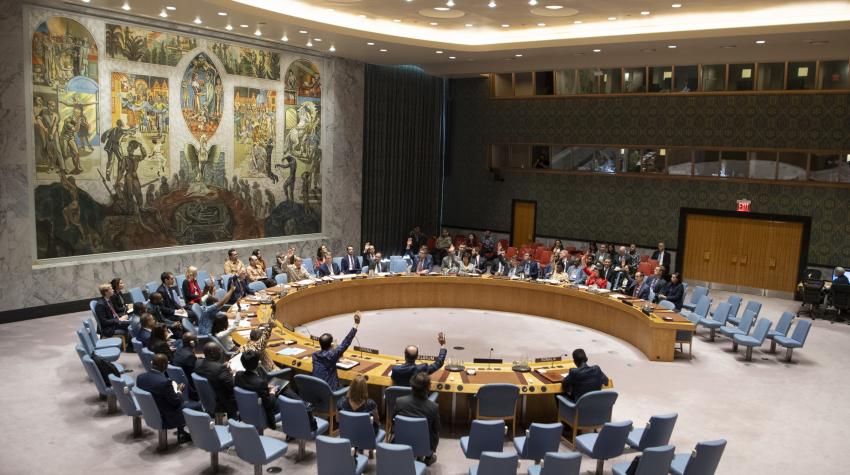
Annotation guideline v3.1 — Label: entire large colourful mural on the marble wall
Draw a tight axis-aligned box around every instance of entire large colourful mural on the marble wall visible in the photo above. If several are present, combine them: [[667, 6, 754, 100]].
[[30, 9, 322, 259]]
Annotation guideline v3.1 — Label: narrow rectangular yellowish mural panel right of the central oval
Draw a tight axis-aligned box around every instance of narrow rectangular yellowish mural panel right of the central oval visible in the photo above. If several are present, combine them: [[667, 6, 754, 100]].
[[233, 87, 278, 183]]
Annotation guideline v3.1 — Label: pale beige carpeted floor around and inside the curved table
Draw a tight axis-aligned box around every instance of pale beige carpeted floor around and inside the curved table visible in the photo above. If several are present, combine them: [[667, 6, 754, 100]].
[[0, 291, 850, 475]]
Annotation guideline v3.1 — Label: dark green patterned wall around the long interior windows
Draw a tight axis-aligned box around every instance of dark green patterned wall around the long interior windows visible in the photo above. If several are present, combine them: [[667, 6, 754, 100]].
[[443, 78, 850, 265]]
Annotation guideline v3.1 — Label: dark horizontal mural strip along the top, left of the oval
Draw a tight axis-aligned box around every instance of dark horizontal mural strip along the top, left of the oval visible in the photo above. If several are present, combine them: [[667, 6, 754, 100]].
[[106, 24, 198, 66]]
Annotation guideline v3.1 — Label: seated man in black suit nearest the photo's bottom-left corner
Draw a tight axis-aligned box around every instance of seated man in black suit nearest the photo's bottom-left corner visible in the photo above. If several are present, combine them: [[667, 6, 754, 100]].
[[136, 354, 200, 444]]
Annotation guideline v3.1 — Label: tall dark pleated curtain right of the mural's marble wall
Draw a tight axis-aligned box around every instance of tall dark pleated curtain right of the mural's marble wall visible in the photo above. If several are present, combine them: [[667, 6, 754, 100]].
[[362, 64, 446, 257]]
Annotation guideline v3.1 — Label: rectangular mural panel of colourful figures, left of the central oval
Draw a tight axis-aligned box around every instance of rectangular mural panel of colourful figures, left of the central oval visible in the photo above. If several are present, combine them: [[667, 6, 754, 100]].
[[109, 72, 170, 181]]
